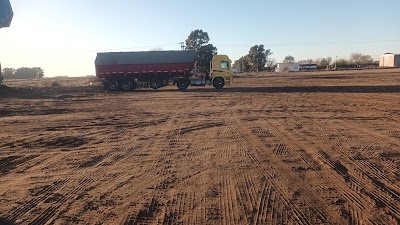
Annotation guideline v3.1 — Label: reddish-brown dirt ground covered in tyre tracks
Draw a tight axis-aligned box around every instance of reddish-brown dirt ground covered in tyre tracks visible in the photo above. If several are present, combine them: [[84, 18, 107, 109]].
[[0, 70, 400, 225]]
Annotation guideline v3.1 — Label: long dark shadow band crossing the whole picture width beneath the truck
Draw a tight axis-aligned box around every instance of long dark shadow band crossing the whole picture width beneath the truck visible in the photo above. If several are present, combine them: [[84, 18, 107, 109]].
[[0, 85, 400, 100]]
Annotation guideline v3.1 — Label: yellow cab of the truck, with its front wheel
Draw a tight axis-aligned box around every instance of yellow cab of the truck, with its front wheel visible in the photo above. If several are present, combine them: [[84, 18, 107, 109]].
[[210, 55, 233, 89]]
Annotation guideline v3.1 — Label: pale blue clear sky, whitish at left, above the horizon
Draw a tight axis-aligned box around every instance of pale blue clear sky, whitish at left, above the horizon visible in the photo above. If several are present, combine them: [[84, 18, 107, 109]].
[[0, 0, 400, 77]]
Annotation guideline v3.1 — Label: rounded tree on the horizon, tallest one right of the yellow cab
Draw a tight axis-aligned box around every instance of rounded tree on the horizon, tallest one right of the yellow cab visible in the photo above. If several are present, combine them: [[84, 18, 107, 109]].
[[247, 44, 272, 72]]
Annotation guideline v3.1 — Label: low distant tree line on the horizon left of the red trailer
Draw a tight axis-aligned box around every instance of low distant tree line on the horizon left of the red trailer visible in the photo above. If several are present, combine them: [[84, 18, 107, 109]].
[[2, 67, 44, 79]]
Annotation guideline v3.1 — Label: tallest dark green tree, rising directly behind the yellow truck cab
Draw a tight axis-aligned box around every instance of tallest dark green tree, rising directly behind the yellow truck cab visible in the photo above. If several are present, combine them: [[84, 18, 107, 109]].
[[186, 29, 217, 71]]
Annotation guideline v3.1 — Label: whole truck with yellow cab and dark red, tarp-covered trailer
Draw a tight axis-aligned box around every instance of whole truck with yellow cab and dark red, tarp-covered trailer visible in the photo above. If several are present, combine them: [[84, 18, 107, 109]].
[[95, 50, 233, 91]]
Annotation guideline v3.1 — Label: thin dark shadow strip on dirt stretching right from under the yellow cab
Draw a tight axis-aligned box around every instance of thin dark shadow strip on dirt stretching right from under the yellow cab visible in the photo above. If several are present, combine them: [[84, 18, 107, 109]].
[[175, 85, 400, 93]]
